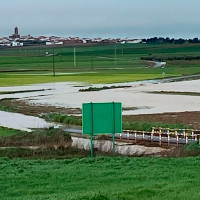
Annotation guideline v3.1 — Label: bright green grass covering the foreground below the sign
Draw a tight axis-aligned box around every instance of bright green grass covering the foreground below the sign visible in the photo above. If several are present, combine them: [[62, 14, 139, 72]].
[[0, 157, 200, 200]]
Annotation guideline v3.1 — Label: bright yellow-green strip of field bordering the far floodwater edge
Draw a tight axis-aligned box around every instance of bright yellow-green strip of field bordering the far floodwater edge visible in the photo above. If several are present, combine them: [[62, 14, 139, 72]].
[[0, 71, 169, 86]]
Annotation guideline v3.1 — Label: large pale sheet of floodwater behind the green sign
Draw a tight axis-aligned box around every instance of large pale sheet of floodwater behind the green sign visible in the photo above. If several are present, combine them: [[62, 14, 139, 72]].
[[0, 80, 200, 115]]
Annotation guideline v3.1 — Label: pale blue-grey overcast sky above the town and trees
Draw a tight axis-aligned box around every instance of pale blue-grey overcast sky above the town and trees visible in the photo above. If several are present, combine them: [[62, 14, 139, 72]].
[[0, 0, 200, 38]]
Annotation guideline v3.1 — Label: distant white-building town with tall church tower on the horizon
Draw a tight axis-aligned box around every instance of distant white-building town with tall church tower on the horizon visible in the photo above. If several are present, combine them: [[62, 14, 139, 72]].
[[0, 27, 141, 47]]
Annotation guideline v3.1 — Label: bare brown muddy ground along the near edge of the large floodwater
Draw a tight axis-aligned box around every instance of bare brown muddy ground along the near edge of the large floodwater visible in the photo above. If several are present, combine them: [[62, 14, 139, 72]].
[[0, 99, 200, 130]]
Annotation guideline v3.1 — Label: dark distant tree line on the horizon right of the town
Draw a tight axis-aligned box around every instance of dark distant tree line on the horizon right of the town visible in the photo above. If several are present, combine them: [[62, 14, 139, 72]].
[[142, 37, 200, 44]]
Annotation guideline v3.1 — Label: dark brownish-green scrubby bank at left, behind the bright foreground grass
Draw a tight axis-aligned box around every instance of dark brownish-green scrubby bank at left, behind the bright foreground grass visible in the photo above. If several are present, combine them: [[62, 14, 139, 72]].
[[0, 127, 89, 159]]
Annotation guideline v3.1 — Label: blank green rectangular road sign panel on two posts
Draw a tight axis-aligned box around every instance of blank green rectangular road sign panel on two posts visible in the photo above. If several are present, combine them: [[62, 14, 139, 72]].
[[82, 102, 122, 135]]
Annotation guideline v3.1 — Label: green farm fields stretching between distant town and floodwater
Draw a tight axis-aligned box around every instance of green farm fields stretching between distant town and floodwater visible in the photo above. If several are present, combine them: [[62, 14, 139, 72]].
[[0, 44, 200, 86]]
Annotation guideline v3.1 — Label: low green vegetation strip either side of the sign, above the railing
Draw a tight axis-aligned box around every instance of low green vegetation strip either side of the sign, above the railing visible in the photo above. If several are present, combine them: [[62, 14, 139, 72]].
[[45, 113, 189, 131]]
